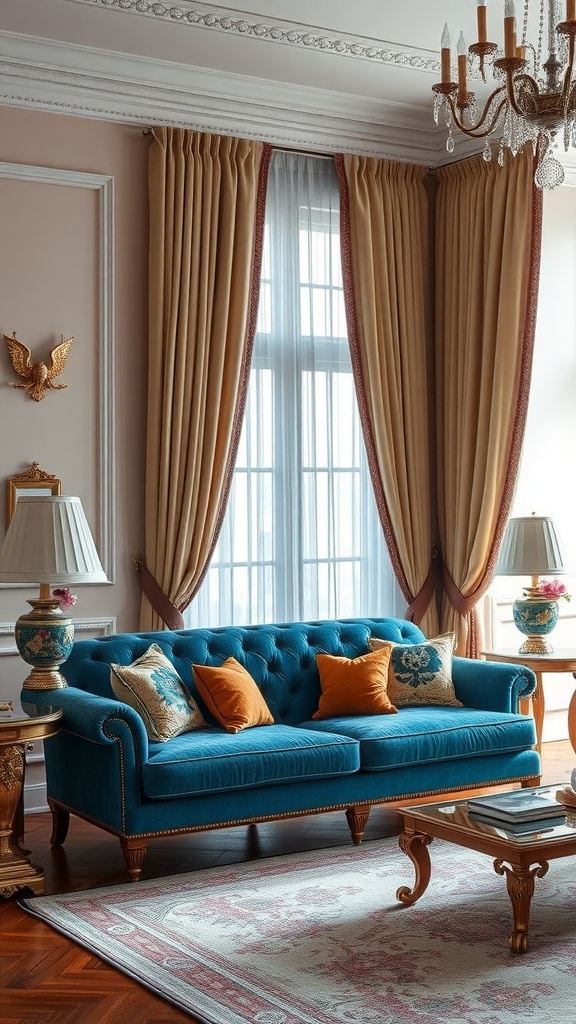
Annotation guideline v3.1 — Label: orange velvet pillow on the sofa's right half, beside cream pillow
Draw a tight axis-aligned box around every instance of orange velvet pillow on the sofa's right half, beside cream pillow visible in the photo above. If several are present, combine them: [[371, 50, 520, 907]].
[[312, 643, 397, 718]]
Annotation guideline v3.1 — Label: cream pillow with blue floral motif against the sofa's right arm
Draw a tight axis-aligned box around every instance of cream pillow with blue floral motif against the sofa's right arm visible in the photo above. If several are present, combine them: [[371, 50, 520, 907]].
[[368, 633, 462, 708]]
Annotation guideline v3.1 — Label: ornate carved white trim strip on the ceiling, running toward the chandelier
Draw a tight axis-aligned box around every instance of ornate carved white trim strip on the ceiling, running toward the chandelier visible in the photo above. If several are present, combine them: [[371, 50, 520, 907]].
[[69, 0, 440, 75]]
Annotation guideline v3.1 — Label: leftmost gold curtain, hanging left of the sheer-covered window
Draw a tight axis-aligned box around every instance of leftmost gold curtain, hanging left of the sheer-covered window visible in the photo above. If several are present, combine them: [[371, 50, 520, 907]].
[[140, 128, 271, 630]]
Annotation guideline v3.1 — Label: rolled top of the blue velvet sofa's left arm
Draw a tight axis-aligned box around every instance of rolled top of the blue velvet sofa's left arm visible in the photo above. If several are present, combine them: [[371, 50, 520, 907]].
[[20, 686, 148, 764]]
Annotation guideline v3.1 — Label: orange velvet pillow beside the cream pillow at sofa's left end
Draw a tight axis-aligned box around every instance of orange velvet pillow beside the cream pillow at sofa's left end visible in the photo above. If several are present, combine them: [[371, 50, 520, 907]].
[[193, 657, 274, 732]]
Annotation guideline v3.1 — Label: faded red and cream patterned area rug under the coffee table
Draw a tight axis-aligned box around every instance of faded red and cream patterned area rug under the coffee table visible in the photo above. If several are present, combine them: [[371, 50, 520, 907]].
[[20, 840, 576, 1024]]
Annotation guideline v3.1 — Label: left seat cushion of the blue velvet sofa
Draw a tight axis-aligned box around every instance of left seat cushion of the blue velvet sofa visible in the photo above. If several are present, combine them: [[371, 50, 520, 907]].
[[142, 725, 360, 800]]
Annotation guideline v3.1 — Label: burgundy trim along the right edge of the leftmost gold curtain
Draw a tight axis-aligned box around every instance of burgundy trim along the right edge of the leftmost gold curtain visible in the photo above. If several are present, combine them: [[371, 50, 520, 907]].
[[180, 142, 273, 611]]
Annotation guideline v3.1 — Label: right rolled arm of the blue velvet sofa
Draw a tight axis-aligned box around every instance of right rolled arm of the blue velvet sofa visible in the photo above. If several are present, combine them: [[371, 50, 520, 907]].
[[452, 657, 536, 714]]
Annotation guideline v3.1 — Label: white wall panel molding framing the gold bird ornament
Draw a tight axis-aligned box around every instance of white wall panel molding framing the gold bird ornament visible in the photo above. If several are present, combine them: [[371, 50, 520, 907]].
[[0, 163, 116, 583]]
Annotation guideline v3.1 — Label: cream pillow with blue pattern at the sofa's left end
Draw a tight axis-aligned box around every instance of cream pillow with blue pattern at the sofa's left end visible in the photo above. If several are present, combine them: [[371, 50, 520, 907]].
[[110, 643, 206, 742]]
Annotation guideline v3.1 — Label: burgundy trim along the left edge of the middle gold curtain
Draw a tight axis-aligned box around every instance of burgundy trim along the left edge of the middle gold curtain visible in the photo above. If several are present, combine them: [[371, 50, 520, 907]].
[[334, 153, 412, 613]]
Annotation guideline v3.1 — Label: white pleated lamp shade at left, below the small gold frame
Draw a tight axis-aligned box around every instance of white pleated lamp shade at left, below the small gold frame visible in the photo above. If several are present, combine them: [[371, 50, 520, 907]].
[[0, 497, 108, 584]]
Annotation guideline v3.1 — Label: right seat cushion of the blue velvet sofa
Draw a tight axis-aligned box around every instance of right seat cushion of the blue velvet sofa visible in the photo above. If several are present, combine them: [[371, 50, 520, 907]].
[[295, 707, 536, 771]]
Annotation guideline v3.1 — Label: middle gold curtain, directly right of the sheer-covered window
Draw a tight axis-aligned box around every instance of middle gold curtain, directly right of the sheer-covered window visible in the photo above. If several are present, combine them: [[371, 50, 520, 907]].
[[335, 156, 438, 636]]
